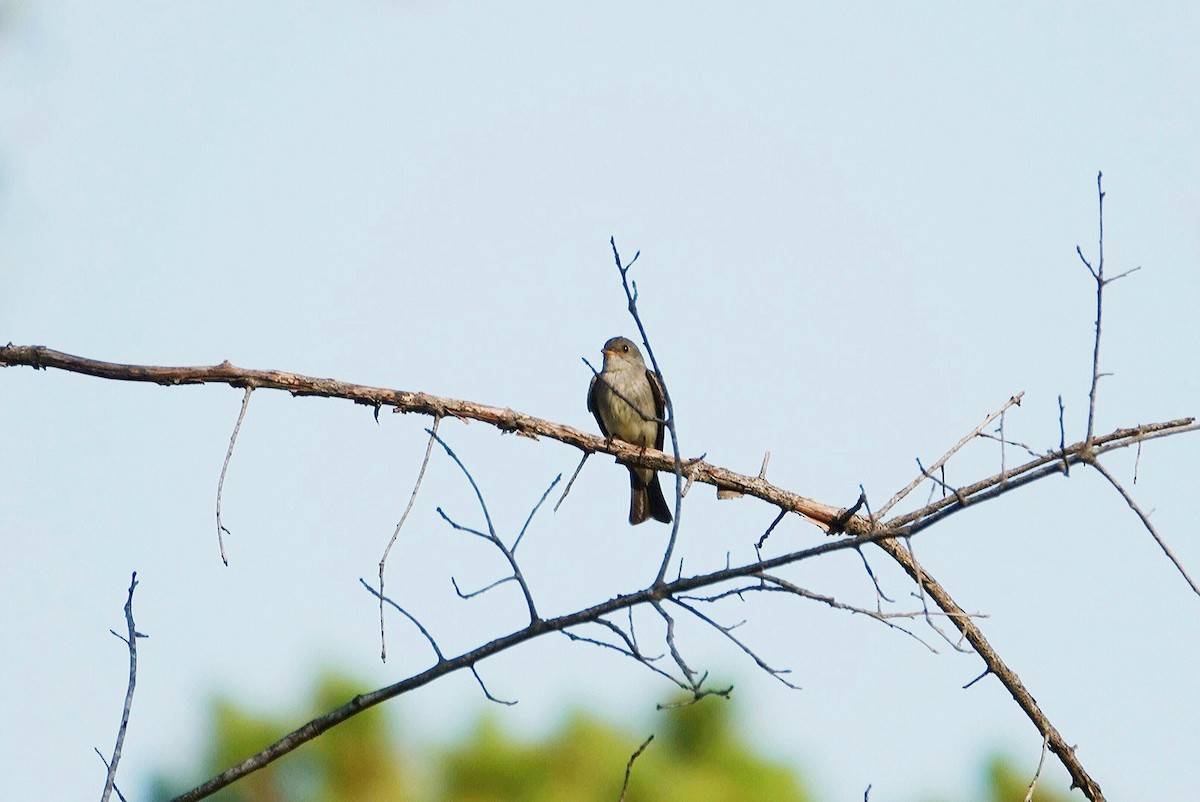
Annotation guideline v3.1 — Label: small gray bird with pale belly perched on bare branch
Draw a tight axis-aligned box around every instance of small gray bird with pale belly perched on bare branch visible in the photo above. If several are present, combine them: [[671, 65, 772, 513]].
[[588, 337, 671, 523]]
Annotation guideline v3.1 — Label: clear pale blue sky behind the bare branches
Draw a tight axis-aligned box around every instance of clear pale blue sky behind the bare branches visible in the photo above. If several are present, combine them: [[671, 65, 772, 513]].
[[0, 6, 1200, 801]]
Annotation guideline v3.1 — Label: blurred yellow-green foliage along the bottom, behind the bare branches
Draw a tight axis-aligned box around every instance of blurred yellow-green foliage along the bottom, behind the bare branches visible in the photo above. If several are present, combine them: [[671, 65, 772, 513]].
[[150, 675, 1079, 802]]
